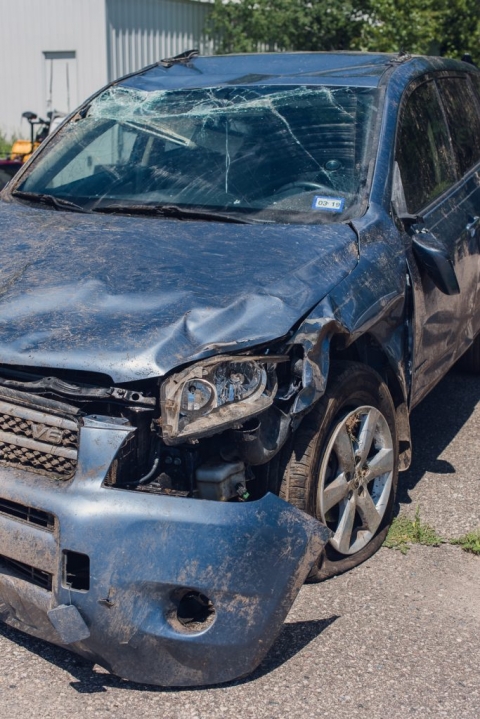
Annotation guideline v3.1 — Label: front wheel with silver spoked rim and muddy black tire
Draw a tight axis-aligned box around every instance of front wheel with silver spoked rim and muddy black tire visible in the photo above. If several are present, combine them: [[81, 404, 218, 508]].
[[279, 362, 398, 582]]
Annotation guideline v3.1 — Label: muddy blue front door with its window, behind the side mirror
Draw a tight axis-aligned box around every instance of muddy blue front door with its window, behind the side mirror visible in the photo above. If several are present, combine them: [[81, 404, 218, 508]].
[[396, 77, 478, 405]]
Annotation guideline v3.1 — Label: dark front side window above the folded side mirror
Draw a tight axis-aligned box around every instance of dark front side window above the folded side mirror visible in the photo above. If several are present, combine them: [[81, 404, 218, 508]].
[[396, 82, 456, 213]]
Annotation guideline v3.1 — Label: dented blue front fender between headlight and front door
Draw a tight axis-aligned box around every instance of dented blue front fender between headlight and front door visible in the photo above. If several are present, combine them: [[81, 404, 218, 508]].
[[291, 205, 410, 423]]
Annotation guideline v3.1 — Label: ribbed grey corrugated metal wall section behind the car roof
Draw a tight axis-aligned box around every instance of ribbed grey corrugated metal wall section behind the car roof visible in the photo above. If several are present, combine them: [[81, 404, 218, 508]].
[[106, 0, 210, 80]]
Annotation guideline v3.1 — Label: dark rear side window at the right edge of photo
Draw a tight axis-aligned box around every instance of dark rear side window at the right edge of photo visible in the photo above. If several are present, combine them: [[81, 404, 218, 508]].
[[437, 77, 480, 175]]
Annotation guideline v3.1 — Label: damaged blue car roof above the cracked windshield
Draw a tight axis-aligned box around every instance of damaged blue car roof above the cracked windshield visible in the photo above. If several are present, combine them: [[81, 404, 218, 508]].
[[117, 51, 472, 91]]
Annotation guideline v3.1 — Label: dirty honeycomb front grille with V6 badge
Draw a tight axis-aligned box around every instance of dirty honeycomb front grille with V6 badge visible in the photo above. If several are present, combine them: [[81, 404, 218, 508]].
[[0, 401, 78, 479]]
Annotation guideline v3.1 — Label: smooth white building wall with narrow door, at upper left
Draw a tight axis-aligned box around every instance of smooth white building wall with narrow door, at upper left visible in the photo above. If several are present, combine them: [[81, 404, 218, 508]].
[[0, 0, 107, 137]]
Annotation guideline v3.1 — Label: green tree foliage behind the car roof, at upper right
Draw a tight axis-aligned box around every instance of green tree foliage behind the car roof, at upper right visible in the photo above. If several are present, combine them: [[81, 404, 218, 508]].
[[207, 0, 480, 64]]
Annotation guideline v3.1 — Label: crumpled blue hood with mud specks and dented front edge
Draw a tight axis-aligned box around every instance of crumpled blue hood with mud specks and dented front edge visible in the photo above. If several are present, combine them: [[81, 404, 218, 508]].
[[0, 202, 358, 382]]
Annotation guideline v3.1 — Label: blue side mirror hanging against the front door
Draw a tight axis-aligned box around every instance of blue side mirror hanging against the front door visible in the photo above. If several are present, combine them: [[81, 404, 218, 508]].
[[412, 230, 460, 295]]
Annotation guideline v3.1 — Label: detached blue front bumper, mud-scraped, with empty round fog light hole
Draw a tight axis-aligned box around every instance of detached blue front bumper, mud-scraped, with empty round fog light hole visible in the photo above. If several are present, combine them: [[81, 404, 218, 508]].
[[0, 418, 330, 686]]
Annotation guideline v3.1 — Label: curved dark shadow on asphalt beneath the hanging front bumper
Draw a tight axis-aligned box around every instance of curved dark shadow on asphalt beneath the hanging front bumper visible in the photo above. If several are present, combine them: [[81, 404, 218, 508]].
[[0, 616, 338, 694]]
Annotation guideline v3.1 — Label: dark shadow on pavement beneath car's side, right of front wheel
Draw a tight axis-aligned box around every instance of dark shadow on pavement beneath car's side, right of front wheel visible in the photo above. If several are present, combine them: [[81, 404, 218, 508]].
[[396, 369, 480, 514]]
